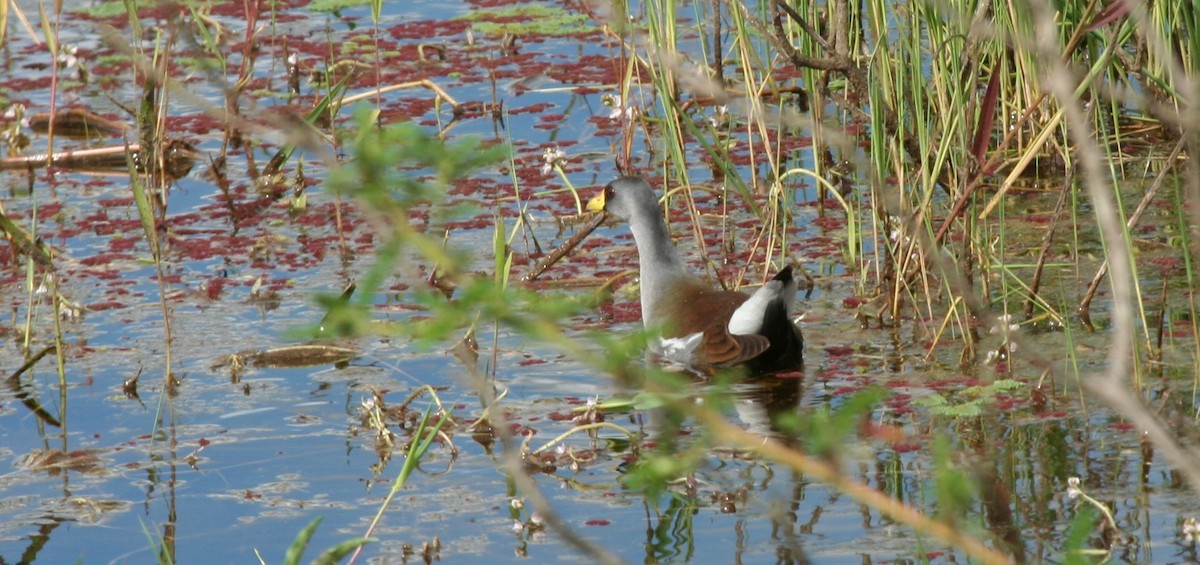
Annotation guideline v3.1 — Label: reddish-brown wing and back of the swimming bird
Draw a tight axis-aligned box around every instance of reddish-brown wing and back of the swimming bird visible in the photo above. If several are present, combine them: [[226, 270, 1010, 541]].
[[652, 281, 770, 367]]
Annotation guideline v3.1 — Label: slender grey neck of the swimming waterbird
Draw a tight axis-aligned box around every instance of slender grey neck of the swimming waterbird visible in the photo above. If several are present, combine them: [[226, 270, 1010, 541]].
[[629, 206, 690, 326]]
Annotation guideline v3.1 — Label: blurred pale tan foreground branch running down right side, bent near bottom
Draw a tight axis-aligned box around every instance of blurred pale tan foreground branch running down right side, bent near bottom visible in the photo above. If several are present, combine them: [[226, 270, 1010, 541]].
[[1032, 0, 1200, 493]]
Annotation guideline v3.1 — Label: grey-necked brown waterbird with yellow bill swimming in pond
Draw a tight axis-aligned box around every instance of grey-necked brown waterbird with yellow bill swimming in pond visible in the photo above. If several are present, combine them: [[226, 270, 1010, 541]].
[[587, 176, 804, 374]]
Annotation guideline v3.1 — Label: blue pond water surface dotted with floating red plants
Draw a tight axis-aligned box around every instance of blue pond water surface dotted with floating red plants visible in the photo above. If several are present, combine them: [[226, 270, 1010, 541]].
[[0, 1, 1195, 563]]
